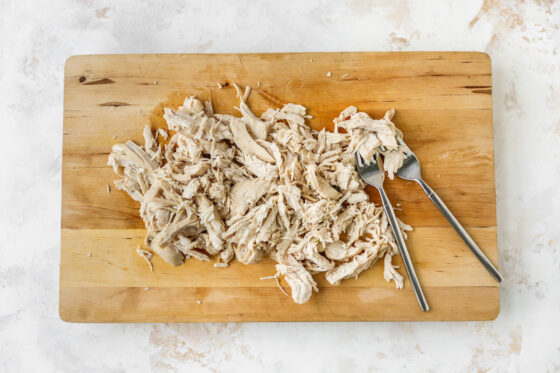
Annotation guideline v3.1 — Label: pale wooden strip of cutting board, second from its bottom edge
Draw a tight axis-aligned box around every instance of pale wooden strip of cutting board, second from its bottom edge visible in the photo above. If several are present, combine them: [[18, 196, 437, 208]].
[[60, 227, 496, 288]]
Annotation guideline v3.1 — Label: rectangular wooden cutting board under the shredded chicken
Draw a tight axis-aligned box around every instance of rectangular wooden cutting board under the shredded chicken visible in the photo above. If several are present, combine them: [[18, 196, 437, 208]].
[[60, 52, 500, 322]]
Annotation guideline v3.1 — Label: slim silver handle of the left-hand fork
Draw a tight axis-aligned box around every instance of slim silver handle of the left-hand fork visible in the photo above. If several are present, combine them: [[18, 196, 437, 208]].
[[378, 187, 430, 312]]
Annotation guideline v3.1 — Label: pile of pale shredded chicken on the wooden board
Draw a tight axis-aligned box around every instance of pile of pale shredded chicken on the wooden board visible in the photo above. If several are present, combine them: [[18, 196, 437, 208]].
[[108, 84, 411, 303]]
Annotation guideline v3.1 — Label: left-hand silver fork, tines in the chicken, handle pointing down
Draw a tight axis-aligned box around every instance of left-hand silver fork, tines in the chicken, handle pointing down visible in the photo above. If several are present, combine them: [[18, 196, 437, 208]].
[[354, 152, 430, 312]]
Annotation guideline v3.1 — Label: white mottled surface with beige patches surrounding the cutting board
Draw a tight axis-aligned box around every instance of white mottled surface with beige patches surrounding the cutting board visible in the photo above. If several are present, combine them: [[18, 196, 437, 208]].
[[0, 0, 560, 372]]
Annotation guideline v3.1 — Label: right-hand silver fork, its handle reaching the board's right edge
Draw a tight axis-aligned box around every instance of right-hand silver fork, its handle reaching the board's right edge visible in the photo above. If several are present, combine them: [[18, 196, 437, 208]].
[[397, 138, 502, 282]]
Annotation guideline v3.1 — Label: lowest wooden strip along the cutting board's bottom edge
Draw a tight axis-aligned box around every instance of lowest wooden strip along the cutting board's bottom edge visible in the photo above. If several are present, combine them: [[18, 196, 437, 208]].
[[60, 286, 499, 322]]
